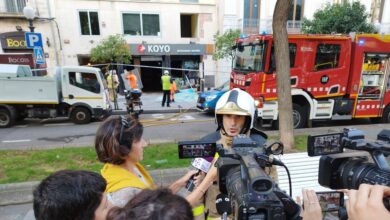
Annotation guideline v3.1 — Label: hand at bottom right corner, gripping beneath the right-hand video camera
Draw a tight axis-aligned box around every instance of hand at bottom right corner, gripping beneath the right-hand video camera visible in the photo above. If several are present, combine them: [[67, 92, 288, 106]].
[[344, 184, 390, 220]]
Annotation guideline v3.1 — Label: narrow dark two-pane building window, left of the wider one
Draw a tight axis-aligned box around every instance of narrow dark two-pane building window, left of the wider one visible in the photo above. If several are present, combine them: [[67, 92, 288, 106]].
[[79, 11, 100, 35]]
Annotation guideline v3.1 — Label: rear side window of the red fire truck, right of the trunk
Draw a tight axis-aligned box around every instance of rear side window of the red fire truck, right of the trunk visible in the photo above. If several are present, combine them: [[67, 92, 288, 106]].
[[314, 44, 341, 71]]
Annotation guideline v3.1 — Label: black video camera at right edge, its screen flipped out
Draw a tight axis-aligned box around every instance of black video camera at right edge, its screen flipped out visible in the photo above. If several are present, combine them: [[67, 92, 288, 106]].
[[307, 128, 390, 189]]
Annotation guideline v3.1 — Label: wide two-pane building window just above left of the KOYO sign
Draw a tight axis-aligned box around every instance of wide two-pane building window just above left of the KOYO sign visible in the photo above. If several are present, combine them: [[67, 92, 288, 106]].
[[122, 13, 160, 36]]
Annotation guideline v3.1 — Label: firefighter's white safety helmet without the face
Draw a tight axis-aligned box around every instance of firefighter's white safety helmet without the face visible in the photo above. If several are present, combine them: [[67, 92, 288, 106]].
[[215, 89, 257, 134]]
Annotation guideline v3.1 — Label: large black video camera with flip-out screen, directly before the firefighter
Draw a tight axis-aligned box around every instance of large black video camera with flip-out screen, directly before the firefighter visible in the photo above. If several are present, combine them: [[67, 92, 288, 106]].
[[179, 135, 300, 220]]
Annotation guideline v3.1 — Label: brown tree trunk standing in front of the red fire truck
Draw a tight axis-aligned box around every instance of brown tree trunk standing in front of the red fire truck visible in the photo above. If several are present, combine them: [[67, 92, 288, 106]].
[[272, 0, 294, 149]]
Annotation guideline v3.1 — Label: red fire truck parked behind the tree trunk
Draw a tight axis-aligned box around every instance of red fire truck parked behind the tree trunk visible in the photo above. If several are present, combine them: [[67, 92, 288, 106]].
[[230, 34, 390, 128]]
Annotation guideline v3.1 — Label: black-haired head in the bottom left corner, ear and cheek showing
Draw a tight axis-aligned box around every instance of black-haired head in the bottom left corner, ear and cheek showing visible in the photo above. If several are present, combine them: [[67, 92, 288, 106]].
[[33, 170, 111, 220]]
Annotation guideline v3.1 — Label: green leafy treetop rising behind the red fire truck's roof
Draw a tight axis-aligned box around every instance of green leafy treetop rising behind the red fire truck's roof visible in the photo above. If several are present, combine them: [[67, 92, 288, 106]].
[[302, 1, 375, 34]]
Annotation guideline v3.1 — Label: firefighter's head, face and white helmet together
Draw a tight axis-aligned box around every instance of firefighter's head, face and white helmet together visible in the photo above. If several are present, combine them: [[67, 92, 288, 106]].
[[215, 89, 256, 137]]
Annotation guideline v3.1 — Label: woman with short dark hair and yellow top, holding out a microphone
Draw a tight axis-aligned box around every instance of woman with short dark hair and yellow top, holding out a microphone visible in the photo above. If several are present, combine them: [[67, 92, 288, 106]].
[[95, 116, 196, 207]]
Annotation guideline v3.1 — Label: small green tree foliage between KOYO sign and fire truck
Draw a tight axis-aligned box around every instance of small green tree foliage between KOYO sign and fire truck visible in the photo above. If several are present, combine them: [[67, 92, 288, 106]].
[[213, 29, 240, 60]]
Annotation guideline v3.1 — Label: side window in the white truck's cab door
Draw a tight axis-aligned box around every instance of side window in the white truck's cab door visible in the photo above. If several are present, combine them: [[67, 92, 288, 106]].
[[69, 72, 100, 93]]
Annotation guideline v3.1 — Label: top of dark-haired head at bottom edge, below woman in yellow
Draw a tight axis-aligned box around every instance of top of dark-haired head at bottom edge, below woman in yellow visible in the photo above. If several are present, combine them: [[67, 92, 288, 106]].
[[107, 189, 194, 220]]
